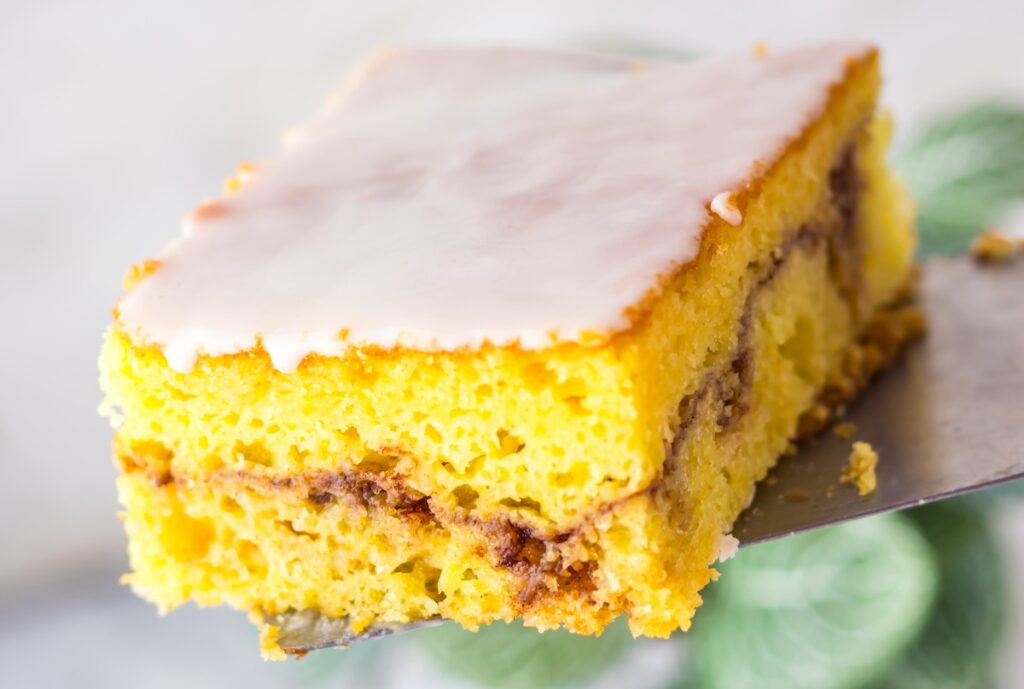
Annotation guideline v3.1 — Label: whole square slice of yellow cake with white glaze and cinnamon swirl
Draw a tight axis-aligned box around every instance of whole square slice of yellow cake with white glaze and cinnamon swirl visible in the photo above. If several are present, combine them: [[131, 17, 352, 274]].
[[100, 43, 914, 655]]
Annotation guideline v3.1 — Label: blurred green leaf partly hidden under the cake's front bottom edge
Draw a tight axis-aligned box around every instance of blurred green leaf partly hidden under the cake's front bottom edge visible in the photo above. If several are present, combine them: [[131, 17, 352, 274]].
[[415, 619, 632, 689]]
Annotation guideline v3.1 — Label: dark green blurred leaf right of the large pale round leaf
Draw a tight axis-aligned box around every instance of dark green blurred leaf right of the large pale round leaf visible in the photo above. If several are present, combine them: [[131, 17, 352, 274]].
[[879, 499, 1008, 689]]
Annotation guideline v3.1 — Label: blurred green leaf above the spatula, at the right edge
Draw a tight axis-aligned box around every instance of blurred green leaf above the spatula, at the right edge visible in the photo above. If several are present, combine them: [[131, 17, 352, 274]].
[[893, 102, 1024, 254]]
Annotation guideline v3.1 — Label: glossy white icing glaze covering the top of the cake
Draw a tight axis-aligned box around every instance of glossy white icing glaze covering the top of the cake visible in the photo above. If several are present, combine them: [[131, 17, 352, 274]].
[[119, 43, 870, 371]]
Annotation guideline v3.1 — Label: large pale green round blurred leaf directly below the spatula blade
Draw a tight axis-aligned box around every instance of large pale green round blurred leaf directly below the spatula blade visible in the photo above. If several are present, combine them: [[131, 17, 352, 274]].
[[690, 515, 936, 689]]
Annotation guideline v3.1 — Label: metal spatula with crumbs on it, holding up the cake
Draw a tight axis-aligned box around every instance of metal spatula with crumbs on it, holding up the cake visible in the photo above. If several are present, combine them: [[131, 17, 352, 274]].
[[267, 259, 1024, 653]]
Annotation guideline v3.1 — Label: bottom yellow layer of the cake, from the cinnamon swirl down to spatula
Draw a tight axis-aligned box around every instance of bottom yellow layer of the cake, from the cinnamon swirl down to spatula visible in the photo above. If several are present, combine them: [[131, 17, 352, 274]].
[[119, 239, 916, 655]]
